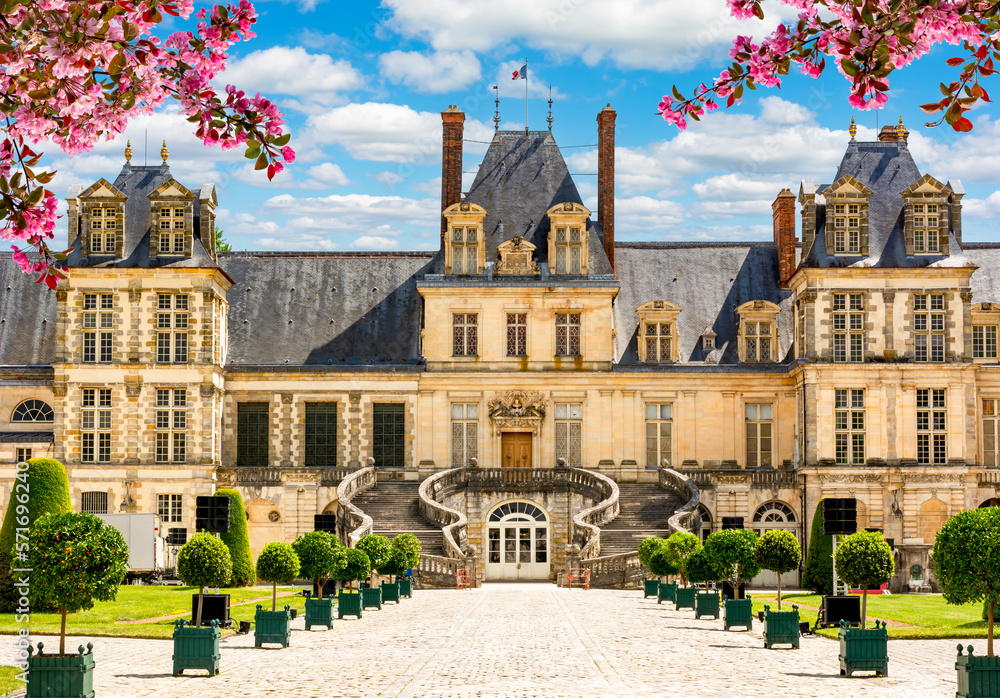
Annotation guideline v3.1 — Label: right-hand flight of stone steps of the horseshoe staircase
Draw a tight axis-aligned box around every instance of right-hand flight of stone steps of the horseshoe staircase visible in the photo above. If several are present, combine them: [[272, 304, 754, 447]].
[[601, 482, 684, 557]]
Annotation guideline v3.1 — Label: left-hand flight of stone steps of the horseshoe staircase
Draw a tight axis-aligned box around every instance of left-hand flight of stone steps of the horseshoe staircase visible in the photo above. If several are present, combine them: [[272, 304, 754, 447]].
[[352, 481, 444, 556]]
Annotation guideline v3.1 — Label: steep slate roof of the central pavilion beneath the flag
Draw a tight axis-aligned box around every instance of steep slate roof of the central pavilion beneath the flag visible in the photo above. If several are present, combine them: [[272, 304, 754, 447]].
[[464, 131, 612, 274]]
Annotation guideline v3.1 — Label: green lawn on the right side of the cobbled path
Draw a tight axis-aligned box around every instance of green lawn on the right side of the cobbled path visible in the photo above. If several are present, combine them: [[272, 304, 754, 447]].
[[751, 593, 988, 639]]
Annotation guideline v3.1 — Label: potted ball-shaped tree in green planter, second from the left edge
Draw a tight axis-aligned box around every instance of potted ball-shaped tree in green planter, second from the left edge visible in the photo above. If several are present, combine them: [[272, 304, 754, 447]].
[[174, 533, 233, 676]]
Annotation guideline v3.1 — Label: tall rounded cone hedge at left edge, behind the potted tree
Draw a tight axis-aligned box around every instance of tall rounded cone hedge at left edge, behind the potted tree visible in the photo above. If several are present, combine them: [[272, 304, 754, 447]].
[[0, 458, 73, 613]]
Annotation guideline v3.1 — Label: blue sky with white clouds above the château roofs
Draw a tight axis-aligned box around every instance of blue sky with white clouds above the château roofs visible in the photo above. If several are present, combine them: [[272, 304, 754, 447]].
[[48, 0, 1000, 250]]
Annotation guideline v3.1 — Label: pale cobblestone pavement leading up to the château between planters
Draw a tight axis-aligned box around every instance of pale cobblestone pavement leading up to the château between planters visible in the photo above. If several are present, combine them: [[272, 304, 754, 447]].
[[0, 583, 986, 698]]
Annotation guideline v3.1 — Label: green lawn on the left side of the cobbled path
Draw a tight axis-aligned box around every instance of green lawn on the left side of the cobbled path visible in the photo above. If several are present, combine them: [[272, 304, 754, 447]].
[[0, 586, 305, 636]]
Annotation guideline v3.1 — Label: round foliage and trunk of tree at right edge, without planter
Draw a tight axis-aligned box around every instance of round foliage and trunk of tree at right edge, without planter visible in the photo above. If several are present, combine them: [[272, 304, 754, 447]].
[[931, 507, 1000, 657]]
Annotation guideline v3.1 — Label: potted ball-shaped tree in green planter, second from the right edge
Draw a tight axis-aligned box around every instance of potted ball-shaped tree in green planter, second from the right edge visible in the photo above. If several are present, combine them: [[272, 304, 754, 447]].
[[834, 531, 896, 676]]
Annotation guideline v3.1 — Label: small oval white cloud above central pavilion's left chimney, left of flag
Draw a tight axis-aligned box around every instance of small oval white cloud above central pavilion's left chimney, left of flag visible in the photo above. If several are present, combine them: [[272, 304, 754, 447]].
[[379, 51, 482, 92]]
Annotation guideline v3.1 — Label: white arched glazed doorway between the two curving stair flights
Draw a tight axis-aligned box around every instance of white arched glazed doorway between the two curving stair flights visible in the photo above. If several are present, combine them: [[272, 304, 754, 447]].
[[485, 500, 551, 580]]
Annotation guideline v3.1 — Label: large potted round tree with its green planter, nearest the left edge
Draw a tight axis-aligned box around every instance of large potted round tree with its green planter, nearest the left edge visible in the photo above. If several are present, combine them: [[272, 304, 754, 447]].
[[25, 513, 128, 696]]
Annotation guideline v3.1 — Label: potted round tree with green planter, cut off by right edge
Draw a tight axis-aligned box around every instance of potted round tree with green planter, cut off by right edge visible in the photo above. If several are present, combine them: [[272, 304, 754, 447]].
[[931, 507, 1000, 698]]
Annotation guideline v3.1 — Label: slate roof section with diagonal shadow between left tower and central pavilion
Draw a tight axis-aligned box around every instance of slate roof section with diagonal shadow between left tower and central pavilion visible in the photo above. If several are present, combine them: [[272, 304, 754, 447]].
[[225, 252, 436, 370]]
